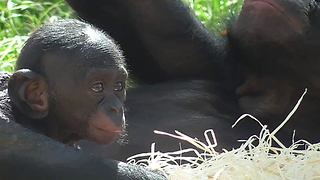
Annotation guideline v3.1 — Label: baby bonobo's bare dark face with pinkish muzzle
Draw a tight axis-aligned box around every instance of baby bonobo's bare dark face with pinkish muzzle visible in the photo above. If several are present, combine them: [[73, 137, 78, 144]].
[[43, 50, 128, 144]]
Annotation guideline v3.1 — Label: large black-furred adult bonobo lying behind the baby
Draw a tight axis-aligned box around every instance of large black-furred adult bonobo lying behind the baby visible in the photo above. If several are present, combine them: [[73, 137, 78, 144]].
[[67, 0, 320, 158]]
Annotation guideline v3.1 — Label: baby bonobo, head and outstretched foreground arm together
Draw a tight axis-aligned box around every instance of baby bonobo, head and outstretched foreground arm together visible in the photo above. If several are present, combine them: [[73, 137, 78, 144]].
[[0, 20, 165, 180]]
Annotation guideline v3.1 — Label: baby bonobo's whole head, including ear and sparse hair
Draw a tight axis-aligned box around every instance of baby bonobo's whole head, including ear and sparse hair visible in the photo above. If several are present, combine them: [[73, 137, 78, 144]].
[[9, 20, 127, 144]]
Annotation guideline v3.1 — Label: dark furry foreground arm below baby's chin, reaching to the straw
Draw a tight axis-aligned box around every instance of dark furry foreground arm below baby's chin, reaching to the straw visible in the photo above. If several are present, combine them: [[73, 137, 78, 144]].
[[0, 119, 165, 180]]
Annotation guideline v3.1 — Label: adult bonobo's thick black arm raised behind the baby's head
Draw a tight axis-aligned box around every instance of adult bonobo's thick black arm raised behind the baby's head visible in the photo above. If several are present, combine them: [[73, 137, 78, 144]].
[[67, 0, 224, 83]]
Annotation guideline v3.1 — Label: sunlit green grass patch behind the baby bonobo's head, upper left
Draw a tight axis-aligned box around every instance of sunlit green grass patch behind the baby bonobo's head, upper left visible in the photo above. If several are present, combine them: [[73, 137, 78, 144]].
[[0, 0, 72, 72]]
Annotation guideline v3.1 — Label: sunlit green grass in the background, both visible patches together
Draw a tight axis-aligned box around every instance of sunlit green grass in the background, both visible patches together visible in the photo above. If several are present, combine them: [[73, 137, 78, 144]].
[[0, 0, 242, 72]]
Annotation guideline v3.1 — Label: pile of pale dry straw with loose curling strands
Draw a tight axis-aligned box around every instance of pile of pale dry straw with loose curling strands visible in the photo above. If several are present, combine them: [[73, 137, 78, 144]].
[[128, 89, 320, 180]]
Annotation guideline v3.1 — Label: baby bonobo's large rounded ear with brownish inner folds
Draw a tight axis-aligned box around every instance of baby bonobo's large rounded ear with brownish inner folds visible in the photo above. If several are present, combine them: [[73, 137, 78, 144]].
[[8, 69, 49, 119]]
